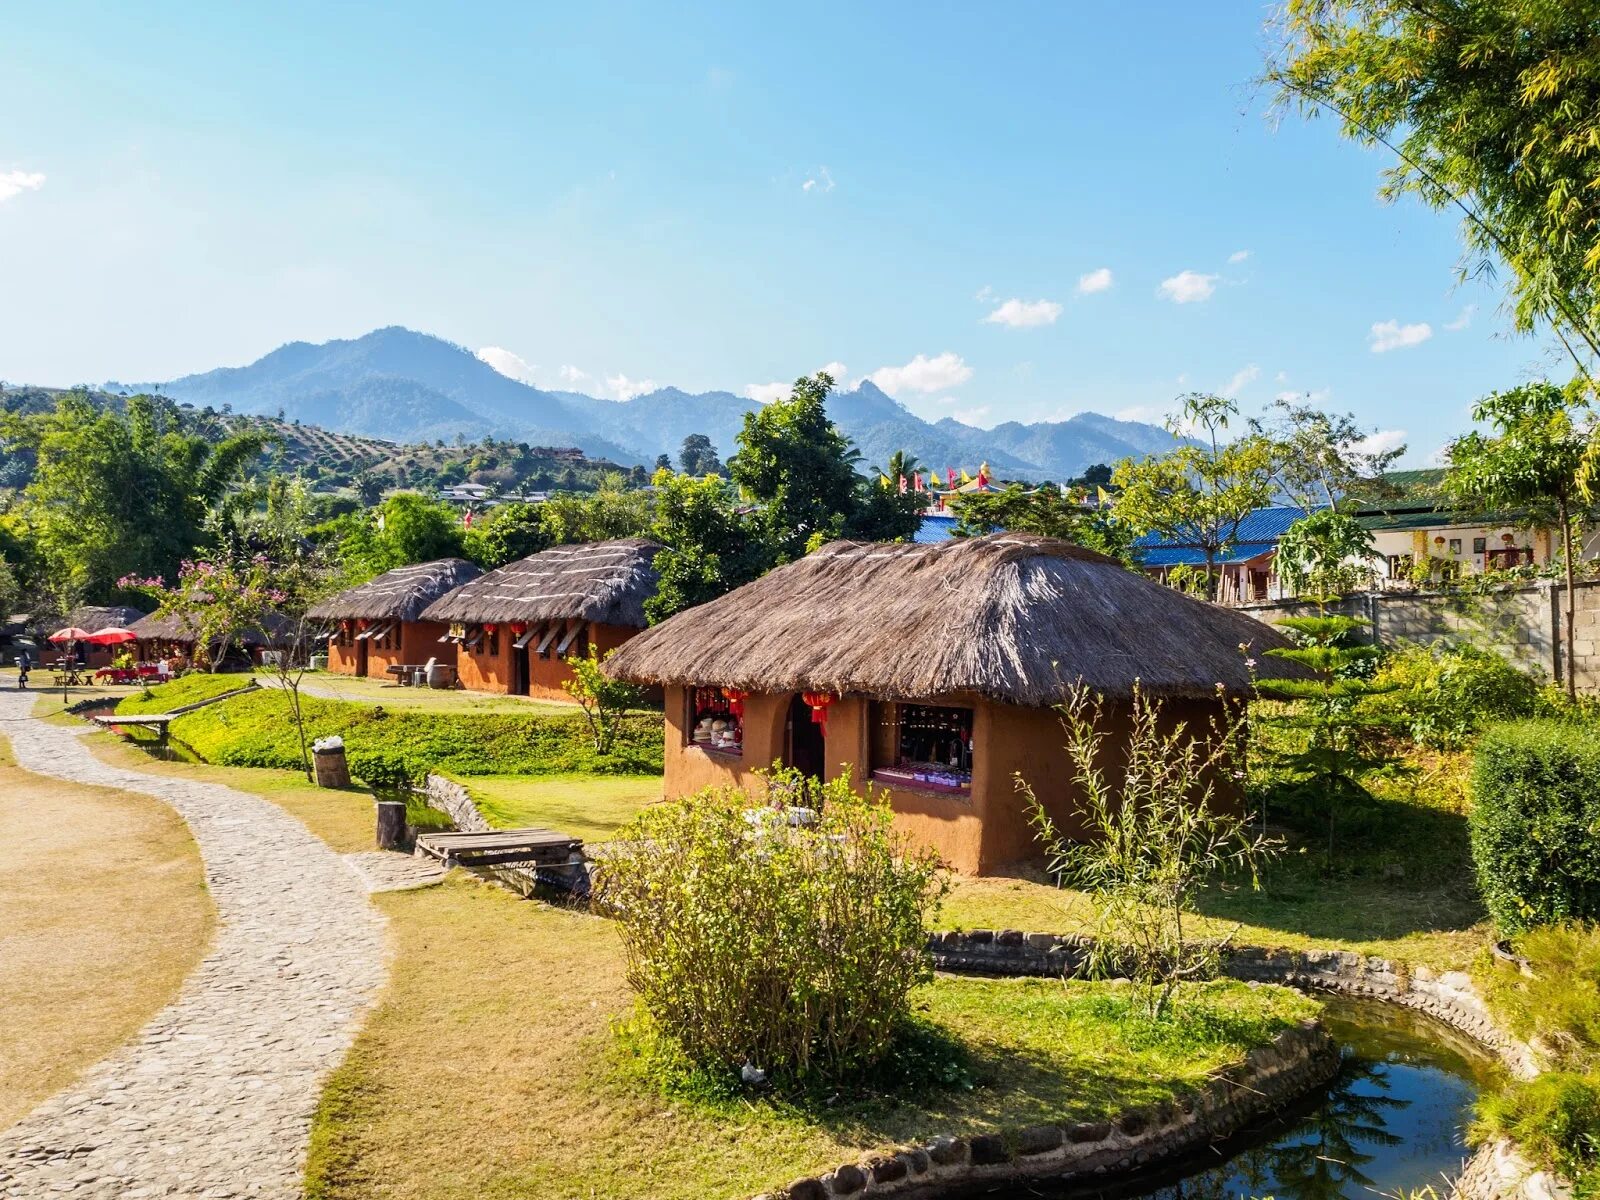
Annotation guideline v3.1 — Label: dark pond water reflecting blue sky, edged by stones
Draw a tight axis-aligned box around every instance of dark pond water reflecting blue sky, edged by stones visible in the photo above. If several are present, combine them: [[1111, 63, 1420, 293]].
[[990, 998, 1498, 1200]]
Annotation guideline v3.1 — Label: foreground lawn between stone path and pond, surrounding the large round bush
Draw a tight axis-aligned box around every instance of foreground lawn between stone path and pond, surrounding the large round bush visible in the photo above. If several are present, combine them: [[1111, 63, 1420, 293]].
[[306, 872, 1318, 1200]]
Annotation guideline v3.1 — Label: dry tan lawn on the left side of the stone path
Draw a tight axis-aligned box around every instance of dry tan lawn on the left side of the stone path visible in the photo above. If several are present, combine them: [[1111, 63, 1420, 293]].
[[0, 739, 214, 1128]]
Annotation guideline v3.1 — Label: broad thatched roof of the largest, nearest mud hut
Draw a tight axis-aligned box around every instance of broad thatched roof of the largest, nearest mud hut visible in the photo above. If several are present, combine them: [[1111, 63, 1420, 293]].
[[608, 533, 1298, 706]]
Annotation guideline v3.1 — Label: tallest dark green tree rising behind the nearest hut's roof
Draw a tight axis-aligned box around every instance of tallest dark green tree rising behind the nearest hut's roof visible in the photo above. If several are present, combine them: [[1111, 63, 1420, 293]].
[[728, 371, 861, 563]]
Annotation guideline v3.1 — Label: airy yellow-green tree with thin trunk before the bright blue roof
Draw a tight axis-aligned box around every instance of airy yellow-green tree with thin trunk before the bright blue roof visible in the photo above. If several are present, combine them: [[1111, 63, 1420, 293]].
[[1112, 392, 1274, 598]]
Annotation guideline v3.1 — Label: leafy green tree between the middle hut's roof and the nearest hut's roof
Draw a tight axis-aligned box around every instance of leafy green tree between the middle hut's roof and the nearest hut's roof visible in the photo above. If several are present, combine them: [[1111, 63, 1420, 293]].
[[645, 470, 773, 624]]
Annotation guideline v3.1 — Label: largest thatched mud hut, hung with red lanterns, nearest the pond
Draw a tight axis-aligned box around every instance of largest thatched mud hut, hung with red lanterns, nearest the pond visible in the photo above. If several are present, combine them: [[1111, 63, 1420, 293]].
[[606, 534, 1293, 874]]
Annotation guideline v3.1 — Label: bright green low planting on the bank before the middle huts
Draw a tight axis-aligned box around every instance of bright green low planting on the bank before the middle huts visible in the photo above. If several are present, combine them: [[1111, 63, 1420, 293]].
[[154, 688, 662, 779]]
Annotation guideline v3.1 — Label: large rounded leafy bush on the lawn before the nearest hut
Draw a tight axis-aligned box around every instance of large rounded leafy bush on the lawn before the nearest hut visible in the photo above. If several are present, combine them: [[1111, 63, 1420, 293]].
[[600, 779, 942, 1083]]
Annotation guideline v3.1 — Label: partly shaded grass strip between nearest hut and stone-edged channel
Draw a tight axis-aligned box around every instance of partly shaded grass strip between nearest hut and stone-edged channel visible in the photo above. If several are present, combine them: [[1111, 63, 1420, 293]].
[[939, 754, 1490, 970]]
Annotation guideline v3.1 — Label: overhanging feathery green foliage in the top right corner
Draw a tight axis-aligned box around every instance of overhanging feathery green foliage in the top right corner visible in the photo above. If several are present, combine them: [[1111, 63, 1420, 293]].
[[1266, 0, 1600, 371]]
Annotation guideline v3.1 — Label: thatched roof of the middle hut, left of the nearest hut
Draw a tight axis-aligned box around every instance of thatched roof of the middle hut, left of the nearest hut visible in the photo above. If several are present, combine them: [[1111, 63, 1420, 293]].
[[426, 538, 661, 629]]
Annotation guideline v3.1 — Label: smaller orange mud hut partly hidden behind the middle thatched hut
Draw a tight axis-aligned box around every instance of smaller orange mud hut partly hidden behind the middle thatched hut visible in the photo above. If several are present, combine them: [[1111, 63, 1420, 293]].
[[307, 558, 482, 677]]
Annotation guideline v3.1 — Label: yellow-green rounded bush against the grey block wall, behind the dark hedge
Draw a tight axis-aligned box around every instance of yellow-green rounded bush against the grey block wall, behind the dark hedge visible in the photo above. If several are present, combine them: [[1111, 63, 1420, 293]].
[[1366, 645, 1539, 750]]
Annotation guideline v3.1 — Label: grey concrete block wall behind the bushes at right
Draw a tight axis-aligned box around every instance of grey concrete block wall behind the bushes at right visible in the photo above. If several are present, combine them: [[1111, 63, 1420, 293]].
[[1238, 581, 1600, 691]]
